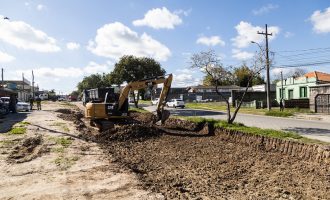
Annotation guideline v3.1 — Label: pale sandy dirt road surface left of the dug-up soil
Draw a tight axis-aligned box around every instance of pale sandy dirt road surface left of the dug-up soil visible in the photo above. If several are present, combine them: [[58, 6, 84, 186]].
[[0, 102, 163, 199]]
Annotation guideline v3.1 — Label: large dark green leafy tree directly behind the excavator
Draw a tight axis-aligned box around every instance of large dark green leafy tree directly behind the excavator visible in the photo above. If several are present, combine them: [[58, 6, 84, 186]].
[[106, 55, 166, 107]]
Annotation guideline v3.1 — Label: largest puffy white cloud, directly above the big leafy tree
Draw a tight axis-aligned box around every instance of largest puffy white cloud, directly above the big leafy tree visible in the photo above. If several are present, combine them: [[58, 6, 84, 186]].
[[87, 22, 171, 61]]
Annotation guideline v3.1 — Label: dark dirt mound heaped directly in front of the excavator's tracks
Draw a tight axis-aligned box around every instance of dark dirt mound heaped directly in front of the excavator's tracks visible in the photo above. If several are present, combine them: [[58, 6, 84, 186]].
[[98, 124, 162, 142]]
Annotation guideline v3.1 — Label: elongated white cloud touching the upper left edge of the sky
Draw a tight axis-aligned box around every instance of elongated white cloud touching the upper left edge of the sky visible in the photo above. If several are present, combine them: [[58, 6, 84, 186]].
[[0, 16, 61, 52]]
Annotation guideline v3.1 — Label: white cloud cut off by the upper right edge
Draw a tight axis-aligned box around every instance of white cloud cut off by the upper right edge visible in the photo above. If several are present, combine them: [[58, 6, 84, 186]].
[[310, 7, 330, 33]]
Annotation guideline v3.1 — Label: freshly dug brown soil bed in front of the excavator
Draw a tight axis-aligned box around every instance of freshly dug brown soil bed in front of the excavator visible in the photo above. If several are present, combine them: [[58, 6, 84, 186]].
[[63, 110, 330, 199]]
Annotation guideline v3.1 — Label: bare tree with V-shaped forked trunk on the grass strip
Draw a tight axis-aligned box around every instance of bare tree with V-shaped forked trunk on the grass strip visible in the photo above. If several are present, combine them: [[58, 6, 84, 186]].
[[191, 50, 265, 124]]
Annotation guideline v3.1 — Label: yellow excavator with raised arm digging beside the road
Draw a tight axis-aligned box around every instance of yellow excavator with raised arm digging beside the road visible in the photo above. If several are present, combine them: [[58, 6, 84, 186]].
[[84, 74, 173, 131]]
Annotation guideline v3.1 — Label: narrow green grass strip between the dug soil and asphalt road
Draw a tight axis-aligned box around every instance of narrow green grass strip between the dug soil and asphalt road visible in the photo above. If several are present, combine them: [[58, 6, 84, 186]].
[[178, 117, 328, 144]]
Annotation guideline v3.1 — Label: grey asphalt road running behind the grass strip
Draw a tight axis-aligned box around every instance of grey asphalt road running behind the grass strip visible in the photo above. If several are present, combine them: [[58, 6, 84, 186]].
[[144, 106, 330, 143]]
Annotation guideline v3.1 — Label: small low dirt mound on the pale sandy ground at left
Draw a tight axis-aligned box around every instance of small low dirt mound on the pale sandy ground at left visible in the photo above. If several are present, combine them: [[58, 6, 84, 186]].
[[8, 135, 47, 163]]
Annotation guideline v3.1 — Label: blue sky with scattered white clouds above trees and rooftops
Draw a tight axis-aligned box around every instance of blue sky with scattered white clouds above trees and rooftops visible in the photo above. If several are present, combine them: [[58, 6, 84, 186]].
[[0, 0, 330, 92]]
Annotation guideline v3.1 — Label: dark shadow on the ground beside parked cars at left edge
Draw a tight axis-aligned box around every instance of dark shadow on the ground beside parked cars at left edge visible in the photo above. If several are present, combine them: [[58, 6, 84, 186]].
[[0, 112, 30, 133]]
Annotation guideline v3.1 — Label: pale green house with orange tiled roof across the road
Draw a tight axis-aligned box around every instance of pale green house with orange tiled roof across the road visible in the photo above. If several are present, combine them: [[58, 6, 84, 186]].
[[276, 71, 330, 102]]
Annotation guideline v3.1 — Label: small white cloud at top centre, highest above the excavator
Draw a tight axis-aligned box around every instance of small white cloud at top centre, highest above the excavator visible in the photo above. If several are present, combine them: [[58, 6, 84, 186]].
[[133, 7, 182, 29]]
